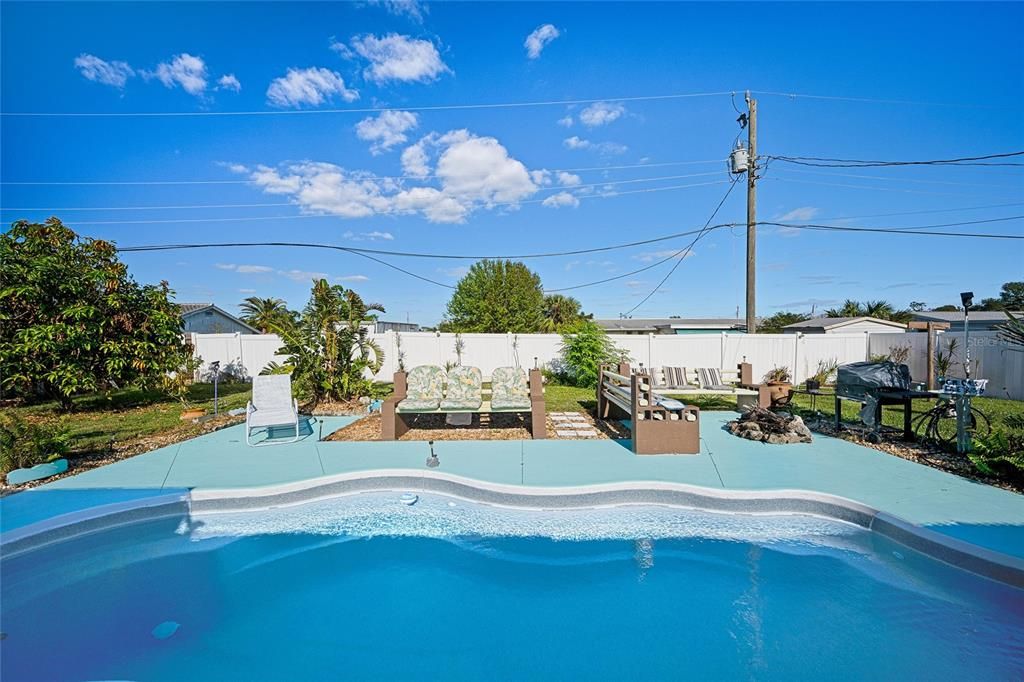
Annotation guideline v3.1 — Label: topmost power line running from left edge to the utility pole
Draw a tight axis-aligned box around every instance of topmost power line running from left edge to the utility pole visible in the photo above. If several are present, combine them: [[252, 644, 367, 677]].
[[0, 90, 735, 118]]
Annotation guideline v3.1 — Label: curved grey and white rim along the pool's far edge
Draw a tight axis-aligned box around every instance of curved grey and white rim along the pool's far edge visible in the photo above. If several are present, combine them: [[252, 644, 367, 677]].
[[0, 469, 1024, 588]]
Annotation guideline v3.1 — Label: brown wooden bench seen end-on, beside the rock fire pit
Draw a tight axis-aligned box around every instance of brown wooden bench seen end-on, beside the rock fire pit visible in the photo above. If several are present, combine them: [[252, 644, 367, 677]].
[[597, 363, 700, 455]]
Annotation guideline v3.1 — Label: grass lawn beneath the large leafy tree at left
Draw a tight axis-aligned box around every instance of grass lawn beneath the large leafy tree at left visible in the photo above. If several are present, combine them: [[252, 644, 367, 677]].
[[9, 383, 251, 456]]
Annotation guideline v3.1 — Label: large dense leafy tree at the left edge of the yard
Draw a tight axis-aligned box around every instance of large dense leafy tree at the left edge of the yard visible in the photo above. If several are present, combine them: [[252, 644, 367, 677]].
[[0, 218, 189, 410]]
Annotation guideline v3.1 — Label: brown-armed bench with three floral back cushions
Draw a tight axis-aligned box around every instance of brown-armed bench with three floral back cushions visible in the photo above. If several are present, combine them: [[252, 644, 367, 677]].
[[381, 365, 547, 440]]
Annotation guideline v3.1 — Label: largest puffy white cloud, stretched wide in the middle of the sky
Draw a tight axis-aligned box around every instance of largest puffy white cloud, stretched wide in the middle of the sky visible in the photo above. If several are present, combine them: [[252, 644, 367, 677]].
[[250, 130, 538, 223]]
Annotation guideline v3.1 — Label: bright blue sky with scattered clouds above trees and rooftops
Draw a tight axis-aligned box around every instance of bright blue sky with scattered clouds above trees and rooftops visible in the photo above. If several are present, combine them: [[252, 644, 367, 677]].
[[0, 2, 1024, 324]]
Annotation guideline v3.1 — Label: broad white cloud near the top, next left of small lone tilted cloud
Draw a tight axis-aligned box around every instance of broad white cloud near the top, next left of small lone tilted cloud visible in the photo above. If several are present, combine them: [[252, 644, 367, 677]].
[[348, 33, 451, 83]]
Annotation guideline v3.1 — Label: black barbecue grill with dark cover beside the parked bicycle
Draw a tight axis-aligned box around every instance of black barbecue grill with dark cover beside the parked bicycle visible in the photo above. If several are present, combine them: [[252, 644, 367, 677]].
[[836, 361, 935, 442]]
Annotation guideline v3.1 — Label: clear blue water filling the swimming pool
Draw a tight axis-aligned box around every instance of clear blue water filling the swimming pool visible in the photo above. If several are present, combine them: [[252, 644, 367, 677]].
[[0, 494, 1024, 682]]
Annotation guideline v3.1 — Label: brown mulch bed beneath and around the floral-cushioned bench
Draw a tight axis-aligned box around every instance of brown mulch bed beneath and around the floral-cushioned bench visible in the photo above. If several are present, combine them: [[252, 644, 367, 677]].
[[324, 413, 629, 441]]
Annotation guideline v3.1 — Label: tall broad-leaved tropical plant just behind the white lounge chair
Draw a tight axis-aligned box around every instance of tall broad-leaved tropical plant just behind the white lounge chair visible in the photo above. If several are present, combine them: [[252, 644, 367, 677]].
[[264, 280, 384, 403]]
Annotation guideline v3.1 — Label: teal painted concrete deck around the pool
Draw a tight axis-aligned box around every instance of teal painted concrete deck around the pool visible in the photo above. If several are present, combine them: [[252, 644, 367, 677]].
[[0, 412, 1024, 557]]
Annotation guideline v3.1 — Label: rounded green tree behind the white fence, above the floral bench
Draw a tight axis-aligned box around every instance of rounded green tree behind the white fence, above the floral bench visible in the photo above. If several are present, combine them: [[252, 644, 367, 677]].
[[441, 260, 544, 334]]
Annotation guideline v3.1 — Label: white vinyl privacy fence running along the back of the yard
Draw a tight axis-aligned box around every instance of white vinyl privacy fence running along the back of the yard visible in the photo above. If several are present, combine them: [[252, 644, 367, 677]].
[[191, 332, 1024, 400]]
